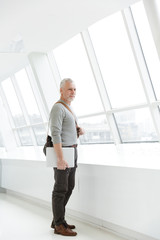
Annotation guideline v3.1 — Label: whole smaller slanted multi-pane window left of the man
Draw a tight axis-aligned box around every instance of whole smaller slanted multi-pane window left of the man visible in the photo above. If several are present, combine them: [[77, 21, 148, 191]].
[[2, 69, 46, 146]]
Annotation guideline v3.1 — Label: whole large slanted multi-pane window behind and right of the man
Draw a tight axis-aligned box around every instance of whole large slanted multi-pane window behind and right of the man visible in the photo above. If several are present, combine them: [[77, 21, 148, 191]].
[[50, 2, 160, 144]]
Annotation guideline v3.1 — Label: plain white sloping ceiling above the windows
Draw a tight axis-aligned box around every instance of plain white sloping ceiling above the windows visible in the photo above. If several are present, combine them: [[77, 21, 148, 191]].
[[0, 0, 138, 79]]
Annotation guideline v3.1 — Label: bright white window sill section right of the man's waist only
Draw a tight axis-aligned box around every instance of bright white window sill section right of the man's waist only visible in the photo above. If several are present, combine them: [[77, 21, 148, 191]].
[[78, 143, 160, 169]]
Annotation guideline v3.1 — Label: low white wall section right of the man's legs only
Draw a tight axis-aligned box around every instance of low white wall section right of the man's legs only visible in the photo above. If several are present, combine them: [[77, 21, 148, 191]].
[[69, 165, 160, 239]]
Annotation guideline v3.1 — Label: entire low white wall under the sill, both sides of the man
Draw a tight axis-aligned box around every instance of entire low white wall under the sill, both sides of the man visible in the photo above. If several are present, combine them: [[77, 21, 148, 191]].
[[1, 156, 160, 240]]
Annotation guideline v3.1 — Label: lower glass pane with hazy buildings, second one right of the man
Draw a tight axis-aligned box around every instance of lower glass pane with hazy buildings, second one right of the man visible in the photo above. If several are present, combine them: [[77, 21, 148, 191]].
[[114, 108, 158, 142]]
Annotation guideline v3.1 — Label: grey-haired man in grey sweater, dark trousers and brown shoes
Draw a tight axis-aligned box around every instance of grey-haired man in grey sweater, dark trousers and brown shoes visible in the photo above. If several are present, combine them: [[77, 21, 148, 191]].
[[50, 78, 84, 236]]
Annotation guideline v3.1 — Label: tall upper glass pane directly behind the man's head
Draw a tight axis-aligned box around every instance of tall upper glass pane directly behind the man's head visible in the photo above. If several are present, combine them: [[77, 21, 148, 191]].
[[53, 35, 103, 115]]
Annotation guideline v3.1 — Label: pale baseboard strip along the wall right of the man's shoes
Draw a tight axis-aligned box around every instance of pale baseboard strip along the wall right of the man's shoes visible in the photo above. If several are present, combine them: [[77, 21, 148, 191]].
[[67, 209, 158, 240]]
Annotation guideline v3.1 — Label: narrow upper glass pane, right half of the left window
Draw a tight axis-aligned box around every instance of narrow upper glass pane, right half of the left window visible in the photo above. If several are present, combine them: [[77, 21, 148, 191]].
[[15, 69, 42, 124]]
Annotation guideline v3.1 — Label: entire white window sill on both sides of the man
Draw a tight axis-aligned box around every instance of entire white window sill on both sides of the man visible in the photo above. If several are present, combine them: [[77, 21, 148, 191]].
[[0, 143, 160, 169]]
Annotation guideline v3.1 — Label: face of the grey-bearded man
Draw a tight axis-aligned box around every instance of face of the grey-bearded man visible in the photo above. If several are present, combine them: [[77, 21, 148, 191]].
[[60, 82, 76, 102]]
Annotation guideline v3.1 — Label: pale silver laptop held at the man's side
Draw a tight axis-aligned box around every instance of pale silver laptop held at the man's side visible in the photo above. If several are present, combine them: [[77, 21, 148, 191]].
[[46, 147, 75, 168]]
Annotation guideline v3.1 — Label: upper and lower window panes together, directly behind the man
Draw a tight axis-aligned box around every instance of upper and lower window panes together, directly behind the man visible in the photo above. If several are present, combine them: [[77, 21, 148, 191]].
[[53, 35, 111, 143]]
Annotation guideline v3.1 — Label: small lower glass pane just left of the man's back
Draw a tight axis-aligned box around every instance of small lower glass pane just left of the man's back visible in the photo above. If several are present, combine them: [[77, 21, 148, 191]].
[[33, 124, 47, 146]]
